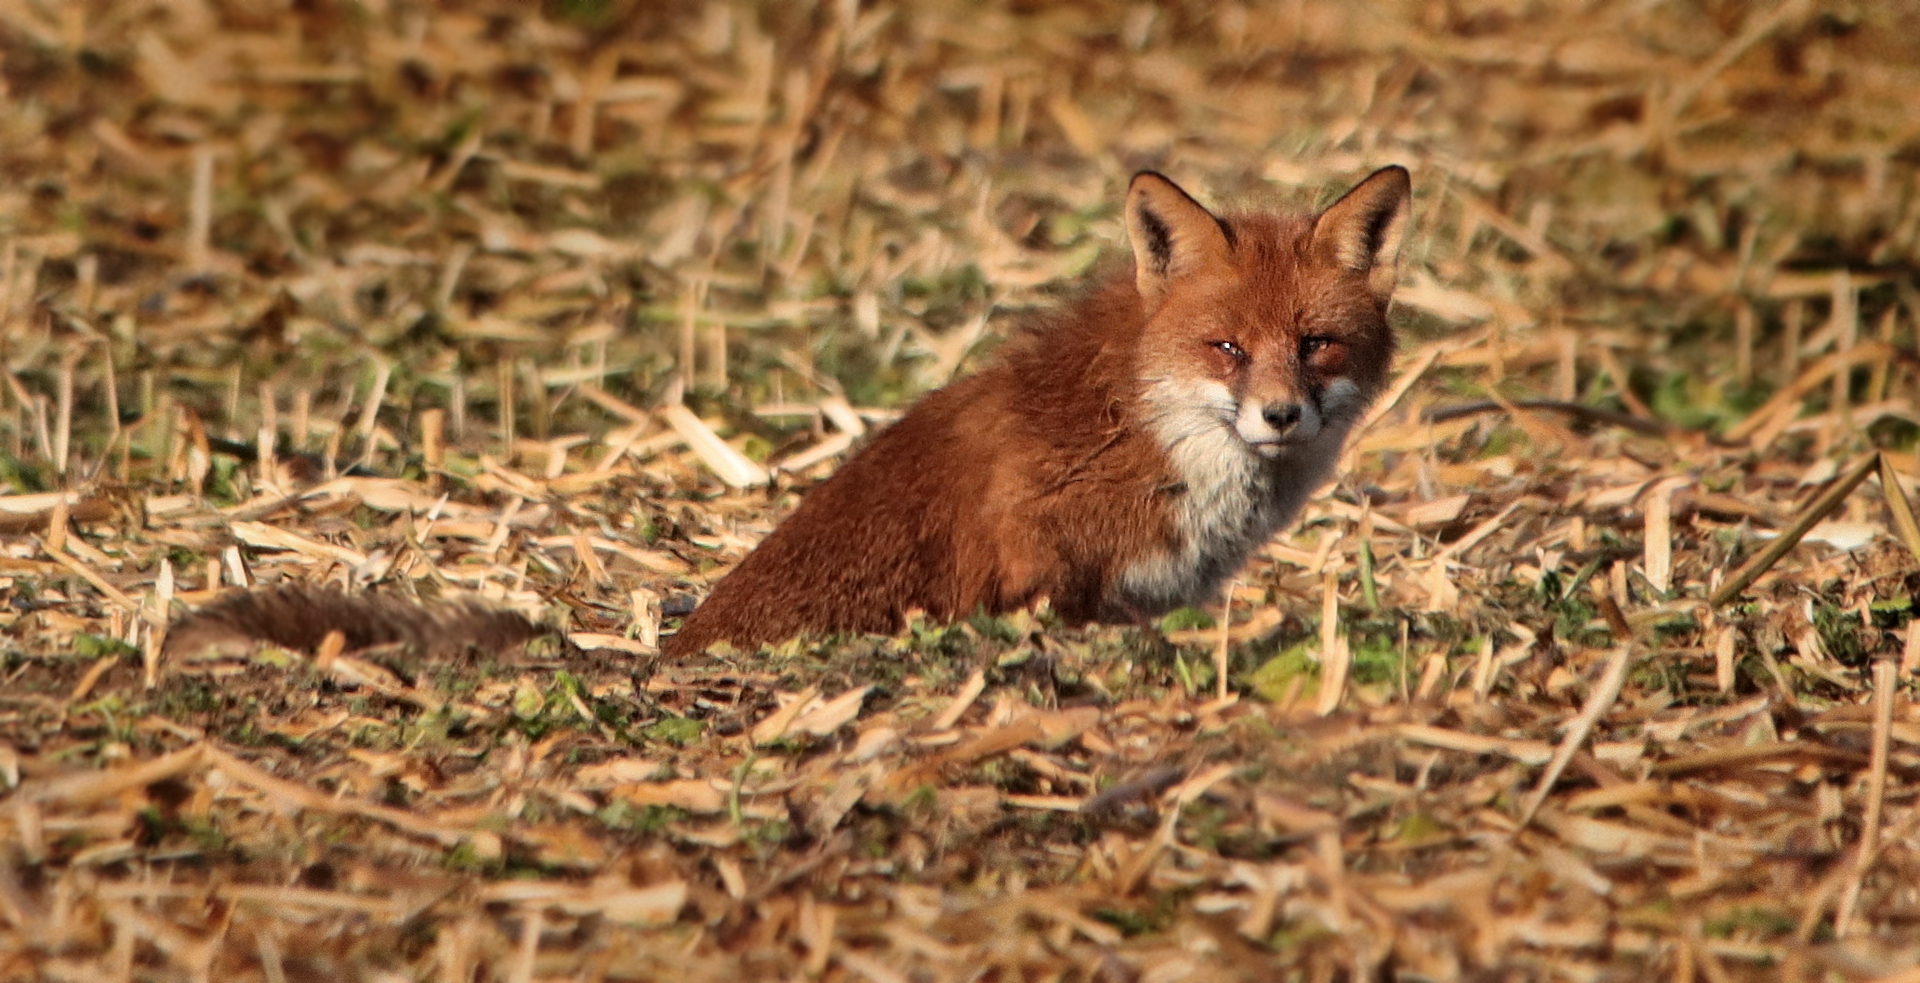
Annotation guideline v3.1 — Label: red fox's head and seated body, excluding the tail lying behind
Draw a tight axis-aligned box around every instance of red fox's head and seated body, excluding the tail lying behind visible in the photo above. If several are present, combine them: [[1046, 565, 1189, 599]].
[[664, 167, 1411, 655]]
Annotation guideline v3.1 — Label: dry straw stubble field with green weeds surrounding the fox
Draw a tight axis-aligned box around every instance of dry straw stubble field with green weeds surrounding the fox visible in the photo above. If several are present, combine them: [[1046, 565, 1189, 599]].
[[0, 0, 1920, 983]]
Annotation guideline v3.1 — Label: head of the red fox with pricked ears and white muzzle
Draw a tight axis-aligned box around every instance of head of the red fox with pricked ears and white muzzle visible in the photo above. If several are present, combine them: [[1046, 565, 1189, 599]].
[[1125, 167, 1411, 461]]
